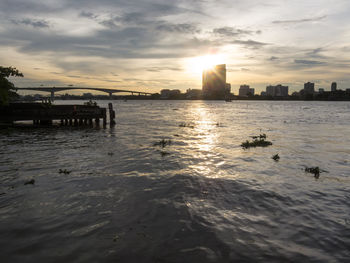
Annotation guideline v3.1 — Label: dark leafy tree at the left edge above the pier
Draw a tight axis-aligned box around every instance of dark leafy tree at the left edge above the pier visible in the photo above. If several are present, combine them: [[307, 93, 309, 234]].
[[0, 66, 23, 105]]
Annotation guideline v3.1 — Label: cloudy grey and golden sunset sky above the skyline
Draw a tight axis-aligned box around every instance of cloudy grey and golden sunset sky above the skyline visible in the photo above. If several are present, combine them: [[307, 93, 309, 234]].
[[0, 0, 350, 94]]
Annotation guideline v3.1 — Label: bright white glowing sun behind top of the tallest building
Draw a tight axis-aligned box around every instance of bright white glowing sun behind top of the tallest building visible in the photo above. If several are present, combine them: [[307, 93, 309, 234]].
[[187, 54, 224, 74]]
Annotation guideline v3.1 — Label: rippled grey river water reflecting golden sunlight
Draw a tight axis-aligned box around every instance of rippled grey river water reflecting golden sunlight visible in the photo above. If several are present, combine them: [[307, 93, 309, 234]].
[[0, 101, 350, 262]]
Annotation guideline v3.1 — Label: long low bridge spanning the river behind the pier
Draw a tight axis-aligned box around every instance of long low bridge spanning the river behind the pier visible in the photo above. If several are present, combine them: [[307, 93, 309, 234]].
[[17, 87, 152, 101]]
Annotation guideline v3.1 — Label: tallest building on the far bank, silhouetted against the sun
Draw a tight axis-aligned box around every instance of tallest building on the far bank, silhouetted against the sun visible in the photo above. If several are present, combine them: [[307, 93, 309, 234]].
[[202, 64, 226, 99]]
